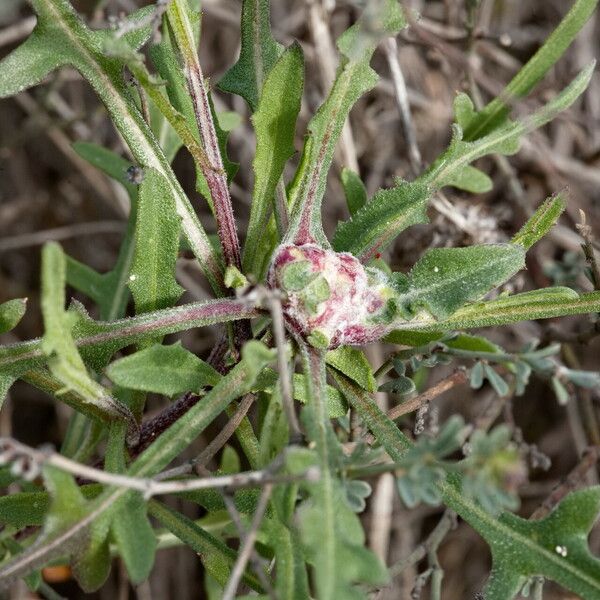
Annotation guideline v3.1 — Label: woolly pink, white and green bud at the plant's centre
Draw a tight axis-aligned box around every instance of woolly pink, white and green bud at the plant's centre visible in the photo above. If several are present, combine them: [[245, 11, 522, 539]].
[[267, 244, 397, 349]]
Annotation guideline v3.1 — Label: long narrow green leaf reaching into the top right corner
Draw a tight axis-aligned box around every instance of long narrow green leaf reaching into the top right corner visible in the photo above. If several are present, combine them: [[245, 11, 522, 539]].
[[464, 0, 598, 141]]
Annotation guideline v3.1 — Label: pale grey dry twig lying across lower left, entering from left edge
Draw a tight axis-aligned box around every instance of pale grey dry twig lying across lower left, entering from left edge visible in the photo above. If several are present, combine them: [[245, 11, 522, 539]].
[[0, 438, 319, 498]]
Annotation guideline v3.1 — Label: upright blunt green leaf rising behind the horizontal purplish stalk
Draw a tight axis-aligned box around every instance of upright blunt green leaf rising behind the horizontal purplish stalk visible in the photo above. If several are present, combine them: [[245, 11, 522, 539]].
[[129, 169, 183, 313]]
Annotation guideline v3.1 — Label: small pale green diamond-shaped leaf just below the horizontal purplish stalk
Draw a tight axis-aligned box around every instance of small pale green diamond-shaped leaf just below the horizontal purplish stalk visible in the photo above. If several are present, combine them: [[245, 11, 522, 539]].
[[106, 342, 221, 396]]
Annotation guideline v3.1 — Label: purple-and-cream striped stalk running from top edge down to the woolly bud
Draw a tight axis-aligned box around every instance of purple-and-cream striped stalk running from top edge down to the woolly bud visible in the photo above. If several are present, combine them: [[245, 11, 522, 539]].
[[167, 0, 242, 269]]
